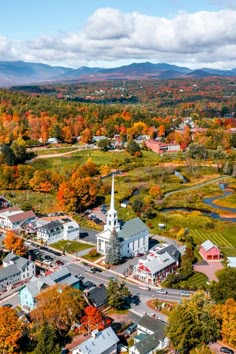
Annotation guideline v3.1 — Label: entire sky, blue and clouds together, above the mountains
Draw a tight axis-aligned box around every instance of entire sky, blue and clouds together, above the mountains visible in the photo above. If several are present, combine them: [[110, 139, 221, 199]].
[[0, 0, 236, 68]]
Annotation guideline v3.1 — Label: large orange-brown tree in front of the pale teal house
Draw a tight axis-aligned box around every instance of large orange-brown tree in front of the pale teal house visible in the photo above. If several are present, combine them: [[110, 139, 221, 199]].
[[31, 284, 85, 335]]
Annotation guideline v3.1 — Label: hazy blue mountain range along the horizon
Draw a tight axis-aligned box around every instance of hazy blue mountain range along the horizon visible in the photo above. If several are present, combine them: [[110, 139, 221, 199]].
[[0, 61, 236, 87]]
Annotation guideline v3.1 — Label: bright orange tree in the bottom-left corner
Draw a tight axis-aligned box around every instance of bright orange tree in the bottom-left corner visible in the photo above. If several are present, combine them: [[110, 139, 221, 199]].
[[0, 306, 24, 354]]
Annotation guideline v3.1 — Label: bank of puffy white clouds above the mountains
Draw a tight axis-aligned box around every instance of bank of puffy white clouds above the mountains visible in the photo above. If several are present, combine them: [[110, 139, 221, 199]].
[[0, 8, 236, 68]]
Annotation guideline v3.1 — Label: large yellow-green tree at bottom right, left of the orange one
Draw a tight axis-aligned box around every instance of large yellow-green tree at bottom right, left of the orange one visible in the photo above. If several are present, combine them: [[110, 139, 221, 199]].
[[166, 292, 220, 354]]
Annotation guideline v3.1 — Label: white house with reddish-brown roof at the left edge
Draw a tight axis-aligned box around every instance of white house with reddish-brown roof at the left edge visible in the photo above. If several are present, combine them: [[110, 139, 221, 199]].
[[0, 207, 36, 230]]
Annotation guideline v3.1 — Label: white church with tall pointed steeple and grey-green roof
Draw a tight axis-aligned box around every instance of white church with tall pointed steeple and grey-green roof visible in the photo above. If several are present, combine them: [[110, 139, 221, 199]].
[[97, 174, 149, 258]]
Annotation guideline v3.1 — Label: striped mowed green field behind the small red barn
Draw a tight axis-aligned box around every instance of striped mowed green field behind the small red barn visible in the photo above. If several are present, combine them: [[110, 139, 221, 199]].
[[190, 226, 236, 256]]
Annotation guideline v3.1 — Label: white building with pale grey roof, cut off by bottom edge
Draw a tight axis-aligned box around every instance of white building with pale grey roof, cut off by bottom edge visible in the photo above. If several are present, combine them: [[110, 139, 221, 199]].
[[71, 327, 119, 354]]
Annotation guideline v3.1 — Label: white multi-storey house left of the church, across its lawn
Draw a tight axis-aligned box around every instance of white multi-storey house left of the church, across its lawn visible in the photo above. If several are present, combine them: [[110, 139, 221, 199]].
[[37, 218, 79, 245]]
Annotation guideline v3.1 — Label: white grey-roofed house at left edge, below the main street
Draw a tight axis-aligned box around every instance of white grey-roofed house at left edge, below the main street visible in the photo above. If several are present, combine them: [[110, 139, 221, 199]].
[[0, 253, 35, 292]]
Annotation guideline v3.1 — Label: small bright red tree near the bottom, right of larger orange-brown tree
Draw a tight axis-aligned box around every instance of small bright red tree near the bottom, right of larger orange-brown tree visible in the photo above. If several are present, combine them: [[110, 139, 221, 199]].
[[80, 306, 104, 333]]
